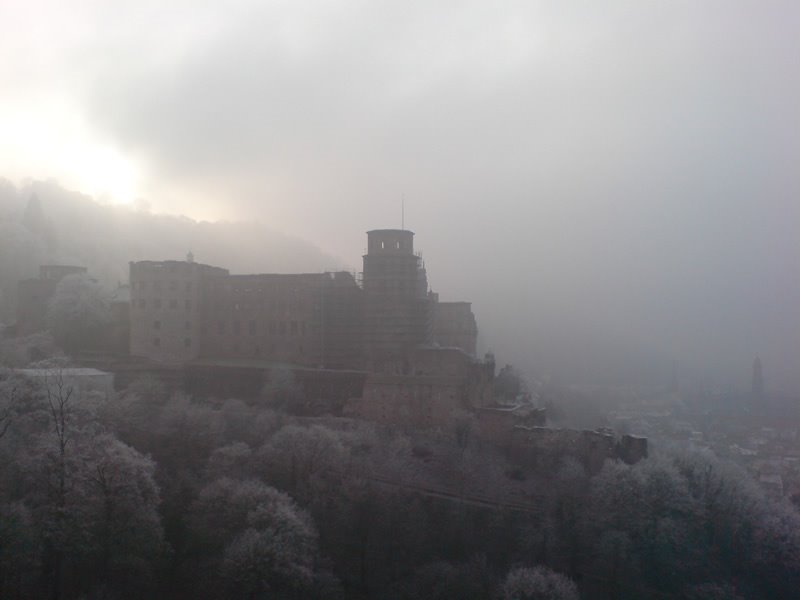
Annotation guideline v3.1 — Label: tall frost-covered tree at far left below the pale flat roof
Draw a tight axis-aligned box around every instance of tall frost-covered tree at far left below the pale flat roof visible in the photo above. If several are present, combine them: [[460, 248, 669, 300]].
[[8, 368, 163, 598]]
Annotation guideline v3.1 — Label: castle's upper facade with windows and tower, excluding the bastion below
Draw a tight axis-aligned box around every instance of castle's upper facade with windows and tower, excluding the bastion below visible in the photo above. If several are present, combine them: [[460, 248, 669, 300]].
[[130, 229, 478, 374]]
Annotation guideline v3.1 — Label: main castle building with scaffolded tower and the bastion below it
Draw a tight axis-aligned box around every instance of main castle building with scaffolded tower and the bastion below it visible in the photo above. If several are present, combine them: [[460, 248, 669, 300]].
[[130, 229, 494, 426]]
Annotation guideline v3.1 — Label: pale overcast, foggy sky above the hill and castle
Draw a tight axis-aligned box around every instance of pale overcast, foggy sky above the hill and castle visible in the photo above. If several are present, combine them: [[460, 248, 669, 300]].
[[0, 0, 800, 386]]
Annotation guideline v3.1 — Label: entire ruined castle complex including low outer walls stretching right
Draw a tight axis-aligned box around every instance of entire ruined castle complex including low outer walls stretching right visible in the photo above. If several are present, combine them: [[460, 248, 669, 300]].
[[12, 229, 647, 470]]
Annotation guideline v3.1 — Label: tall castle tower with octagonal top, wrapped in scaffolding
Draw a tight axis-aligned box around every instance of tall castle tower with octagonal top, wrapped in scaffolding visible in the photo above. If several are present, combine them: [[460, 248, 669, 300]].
[[364, 229, 431, 361]]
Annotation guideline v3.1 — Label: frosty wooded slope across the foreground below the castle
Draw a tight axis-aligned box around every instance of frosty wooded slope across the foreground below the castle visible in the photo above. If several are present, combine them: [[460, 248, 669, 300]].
[[0, 362, 800, 600]]
